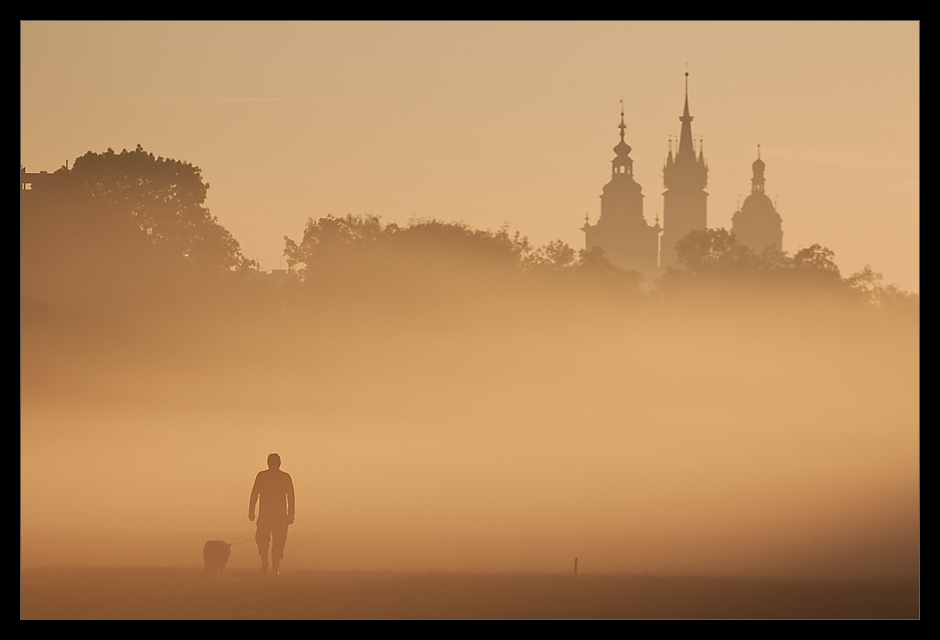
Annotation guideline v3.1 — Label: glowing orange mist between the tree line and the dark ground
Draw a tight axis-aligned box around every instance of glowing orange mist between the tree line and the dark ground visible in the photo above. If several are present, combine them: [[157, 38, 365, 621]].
[[21, 216, 919, 577]]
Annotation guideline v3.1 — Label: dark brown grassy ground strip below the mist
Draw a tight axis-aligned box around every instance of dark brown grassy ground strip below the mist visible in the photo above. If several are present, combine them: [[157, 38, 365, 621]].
[[20, 568, 920, 619]]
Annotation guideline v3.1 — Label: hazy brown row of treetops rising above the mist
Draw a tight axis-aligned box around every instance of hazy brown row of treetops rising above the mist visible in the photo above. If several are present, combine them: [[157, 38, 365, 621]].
[[21, 145, 918, 310]]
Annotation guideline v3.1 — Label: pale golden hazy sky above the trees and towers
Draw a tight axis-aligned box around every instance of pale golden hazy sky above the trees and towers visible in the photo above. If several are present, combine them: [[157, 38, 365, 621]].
[[20, 22, 920, 291]]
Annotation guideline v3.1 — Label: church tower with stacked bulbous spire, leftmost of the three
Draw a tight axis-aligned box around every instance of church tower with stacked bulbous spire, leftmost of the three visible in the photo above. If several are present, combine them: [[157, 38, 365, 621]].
[[582, 101, 659, 276]]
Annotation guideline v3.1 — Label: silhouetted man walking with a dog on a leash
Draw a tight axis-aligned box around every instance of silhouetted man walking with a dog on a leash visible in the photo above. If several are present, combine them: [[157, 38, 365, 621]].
[[248, 453, 294, 575]]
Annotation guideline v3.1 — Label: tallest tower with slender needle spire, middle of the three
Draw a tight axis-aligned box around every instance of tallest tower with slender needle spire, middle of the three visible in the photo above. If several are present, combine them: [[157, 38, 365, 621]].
[[659, 71, 708, 267]]
